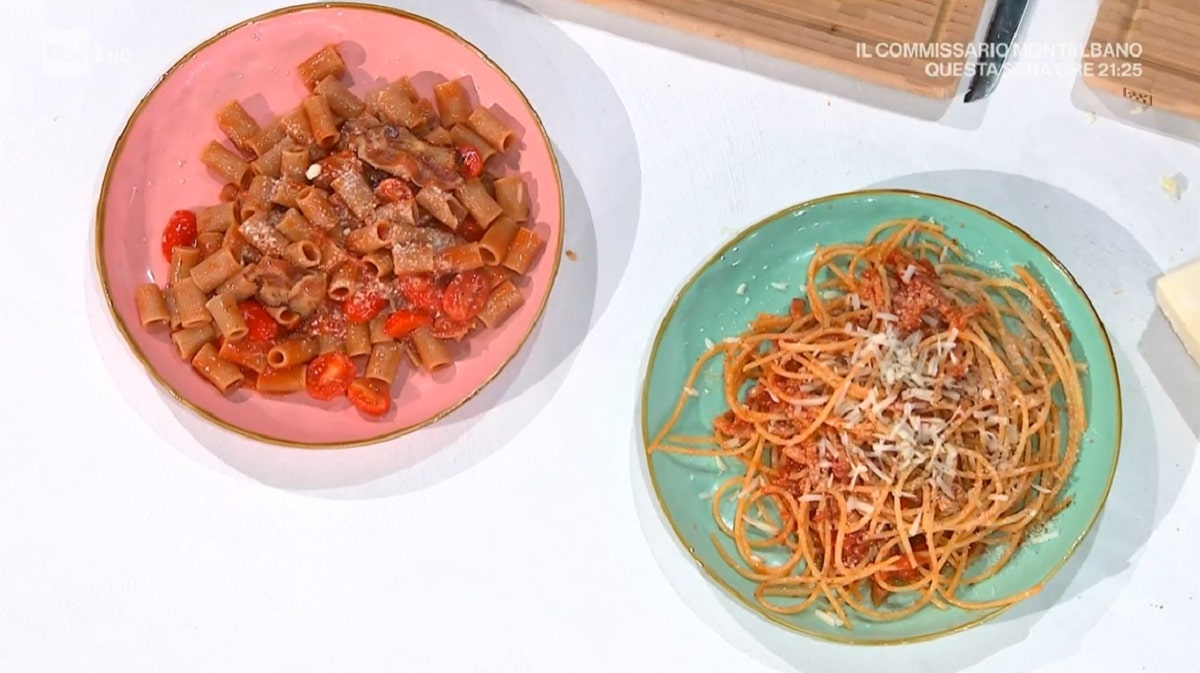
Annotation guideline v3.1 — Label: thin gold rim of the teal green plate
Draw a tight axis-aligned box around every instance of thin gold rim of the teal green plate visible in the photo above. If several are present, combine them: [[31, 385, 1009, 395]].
[[638, 187, 1124, 647]]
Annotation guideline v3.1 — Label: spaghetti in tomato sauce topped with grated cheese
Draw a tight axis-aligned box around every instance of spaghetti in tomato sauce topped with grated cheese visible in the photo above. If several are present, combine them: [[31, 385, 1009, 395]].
[[647, 220, 1086, 629]]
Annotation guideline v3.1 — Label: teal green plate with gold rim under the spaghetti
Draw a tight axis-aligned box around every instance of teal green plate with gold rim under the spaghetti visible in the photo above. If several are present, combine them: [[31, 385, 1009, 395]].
[[642, 190, 1121, 644]]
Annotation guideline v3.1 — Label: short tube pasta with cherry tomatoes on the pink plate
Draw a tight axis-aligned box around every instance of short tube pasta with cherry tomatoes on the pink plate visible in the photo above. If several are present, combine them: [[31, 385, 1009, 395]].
[[134, 46, 544, 416]]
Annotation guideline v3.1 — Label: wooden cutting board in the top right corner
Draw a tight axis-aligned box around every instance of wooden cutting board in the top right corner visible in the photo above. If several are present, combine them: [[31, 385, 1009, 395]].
[[1082, 0, 1200, 119]]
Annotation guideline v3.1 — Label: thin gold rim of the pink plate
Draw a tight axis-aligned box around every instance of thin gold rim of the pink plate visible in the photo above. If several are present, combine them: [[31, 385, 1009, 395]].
[[92, 1, 566, 450]]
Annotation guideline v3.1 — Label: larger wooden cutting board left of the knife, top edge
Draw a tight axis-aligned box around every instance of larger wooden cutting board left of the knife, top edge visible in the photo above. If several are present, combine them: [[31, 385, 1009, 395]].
[[566, 0, 988, 98]]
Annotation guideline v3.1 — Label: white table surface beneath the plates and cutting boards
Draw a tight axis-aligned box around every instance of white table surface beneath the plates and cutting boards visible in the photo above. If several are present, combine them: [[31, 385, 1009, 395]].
[[0, 0, 1200, 673]]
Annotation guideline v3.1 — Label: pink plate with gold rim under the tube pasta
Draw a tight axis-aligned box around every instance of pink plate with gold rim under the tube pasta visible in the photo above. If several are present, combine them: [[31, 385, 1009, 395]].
[[96, 4, 563, 447]]
